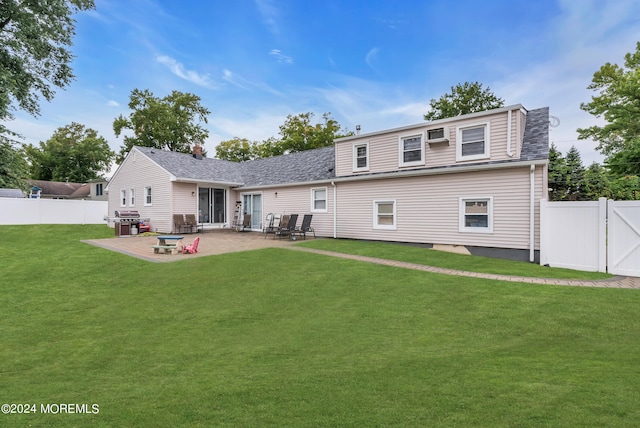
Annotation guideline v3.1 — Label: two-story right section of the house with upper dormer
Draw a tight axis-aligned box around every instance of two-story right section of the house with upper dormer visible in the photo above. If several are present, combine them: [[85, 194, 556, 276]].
[[334, 104, 549, 261]]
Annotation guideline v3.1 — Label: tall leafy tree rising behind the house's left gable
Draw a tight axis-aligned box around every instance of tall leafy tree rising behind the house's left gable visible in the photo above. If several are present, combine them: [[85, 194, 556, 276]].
[[113, 89, 210, 163]]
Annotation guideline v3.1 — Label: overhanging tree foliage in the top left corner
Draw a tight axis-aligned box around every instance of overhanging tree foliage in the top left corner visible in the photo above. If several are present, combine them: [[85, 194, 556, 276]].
[[0, 0, 95, 137]]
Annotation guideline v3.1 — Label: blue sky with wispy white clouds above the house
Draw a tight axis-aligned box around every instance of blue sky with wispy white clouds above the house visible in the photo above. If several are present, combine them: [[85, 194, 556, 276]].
[[7, 0, 640, 169]]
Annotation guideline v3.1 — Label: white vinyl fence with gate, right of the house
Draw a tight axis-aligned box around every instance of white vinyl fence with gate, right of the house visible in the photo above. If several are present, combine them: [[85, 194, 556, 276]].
[[540, 198, 640, 276]]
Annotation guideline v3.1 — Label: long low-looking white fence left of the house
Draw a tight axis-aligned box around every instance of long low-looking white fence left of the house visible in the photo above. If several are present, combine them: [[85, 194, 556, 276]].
[[0, 198, 109, 224]]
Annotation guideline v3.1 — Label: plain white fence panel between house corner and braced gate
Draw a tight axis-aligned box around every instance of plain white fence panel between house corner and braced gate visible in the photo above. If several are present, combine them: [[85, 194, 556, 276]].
[[540, 198, 607, 272]]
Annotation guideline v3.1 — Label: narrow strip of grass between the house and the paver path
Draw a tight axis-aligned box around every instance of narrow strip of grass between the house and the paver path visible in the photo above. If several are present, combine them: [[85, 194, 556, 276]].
[[298, 239, 613, 280]]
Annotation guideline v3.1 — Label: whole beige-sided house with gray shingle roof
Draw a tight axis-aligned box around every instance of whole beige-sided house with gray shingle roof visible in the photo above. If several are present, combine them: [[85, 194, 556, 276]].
[[108, 104, 549, 261]]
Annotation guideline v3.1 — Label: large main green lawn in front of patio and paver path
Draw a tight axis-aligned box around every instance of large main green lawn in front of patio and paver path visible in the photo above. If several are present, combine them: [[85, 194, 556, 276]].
[[0, 225, 640, 427]]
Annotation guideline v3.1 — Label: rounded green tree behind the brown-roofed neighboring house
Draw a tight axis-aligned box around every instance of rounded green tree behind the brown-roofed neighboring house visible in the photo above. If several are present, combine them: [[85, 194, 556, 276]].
[[25, 122, 115, 183]]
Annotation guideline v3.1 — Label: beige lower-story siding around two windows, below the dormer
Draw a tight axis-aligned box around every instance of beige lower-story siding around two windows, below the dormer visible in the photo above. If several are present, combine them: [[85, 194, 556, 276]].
[[337, 167, 543, 249]]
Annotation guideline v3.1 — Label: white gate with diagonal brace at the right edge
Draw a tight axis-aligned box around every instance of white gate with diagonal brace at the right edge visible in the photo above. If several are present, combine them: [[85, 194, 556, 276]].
[[608, 201, 640, 276]]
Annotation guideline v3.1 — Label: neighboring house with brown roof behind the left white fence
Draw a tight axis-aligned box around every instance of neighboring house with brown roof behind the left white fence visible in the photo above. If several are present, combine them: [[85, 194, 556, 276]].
[[27, 179, 108, 201]]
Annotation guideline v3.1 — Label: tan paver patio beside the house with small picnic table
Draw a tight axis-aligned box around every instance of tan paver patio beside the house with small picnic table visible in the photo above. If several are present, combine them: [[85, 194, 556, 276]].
[[84, 229, 298, 263]]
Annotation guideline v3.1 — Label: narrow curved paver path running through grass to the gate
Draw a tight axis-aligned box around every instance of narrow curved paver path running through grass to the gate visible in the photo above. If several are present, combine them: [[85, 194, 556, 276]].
[[287, 246, 640, 289]]
